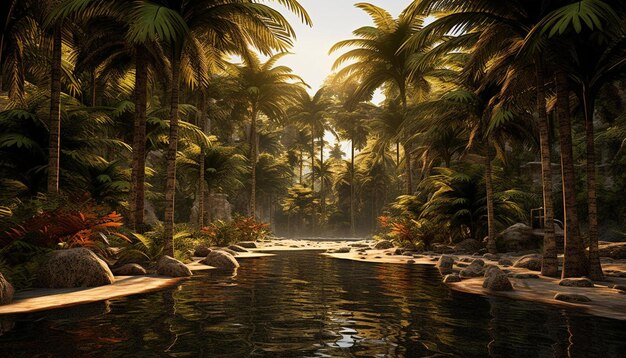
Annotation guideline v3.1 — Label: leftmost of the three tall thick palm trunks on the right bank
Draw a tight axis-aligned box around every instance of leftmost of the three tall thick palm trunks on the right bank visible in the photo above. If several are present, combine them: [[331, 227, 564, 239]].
[[535, 57, 559, 277]]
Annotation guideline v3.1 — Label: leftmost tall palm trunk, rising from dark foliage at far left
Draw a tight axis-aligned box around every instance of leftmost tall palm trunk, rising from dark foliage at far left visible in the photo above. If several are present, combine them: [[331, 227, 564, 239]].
[[48, 25, 63, 194]]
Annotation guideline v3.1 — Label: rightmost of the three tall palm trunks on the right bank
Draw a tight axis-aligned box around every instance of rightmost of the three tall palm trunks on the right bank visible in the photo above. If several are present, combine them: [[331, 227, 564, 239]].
[[582, 85, 604, 280]]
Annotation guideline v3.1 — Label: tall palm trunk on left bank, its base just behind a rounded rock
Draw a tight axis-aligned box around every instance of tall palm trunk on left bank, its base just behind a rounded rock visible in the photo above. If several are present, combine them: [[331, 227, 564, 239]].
[[163, 55, 180, 256]]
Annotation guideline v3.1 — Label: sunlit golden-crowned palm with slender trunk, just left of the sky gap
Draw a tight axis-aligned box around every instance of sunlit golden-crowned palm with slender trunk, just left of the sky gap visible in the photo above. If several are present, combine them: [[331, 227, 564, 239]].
[[232, 52, 304, 216]]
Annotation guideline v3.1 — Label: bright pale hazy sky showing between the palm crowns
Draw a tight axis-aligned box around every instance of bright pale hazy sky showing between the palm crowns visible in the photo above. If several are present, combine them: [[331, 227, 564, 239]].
[[270, 0, 411, 92]]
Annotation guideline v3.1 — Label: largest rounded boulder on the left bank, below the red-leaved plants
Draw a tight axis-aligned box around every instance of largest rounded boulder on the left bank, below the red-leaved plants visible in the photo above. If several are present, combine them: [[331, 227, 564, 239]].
[[37, 247, 115, 288]]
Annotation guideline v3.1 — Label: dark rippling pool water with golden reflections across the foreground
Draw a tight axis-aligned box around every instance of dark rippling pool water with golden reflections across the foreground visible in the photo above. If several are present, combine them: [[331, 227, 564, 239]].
[[0, 252, 626, 358]]
